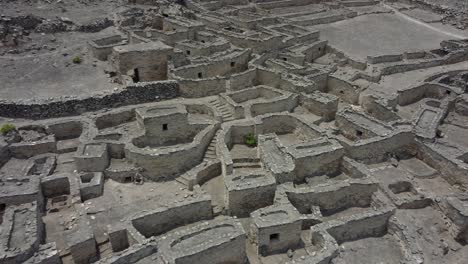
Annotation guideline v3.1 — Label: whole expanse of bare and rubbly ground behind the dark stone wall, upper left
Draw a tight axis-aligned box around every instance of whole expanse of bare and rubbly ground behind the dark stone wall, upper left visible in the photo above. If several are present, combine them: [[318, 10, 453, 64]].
[[0, 0, 191, 100]]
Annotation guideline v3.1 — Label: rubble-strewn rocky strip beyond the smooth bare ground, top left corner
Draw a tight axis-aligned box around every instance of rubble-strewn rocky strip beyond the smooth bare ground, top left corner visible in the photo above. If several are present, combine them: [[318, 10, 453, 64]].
[[0, 0, 125, 55]]
